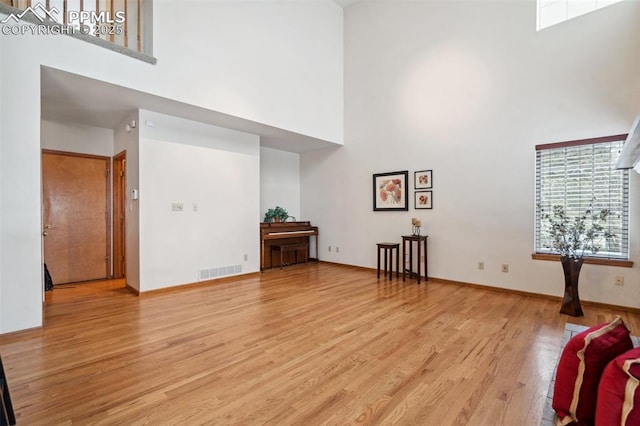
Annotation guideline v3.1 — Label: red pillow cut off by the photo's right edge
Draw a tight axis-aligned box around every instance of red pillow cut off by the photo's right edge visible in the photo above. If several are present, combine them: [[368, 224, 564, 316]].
[[596, 348, 640, 426]]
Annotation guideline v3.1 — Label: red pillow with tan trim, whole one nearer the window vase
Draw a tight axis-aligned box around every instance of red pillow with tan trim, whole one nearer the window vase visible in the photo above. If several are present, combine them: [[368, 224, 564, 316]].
[[552, 317, 633, 425]]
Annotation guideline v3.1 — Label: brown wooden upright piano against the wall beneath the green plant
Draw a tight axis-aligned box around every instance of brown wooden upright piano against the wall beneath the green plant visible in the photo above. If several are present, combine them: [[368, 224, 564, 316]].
[[260, 222, 318, 271]]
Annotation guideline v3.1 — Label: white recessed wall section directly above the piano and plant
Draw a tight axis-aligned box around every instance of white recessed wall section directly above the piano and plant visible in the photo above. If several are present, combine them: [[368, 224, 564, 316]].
[[259, 148, 305, 221]]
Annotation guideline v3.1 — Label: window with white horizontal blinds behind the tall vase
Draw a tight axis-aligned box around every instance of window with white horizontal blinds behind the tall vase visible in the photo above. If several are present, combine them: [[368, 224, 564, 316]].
[[535, 135, 629, 259]]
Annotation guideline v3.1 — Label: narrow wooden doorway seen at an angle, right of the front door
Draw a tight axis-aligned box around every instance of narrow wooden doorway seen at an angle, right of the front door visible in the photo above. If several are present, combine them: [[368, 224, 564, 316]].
[[111, 150, 127, 278]]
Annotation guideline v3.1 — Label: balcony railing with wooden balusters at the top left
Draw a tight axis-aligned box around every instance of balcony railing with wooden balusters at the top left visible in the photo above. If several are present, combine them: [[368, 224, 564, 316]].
[[0, 0, 152, 56]]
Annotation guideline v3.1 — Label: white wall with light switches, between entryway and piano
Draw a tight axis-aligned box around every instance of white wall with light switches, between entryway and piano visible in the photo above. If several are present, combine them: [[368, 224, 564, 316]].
[[140, 110, 260, 292]]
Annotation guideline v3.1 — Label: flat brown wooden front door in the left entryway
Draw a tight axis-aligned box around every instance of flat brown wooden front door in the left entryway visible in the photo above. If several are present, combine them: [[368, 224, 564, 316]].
[[42, 151, 111, 284]]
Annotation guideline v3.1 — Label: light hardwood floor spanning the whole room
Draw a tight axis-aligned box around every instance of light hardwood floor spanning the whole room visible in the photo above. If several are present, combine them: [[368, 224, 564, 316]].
[[0, 263, 640, 426]]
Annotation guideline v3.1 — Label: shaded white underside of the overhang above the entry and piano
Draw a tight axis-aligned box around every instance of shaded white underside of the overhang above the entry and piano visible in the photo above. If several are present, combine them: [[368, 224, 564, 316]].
[[40, 66, 341, 153]]
